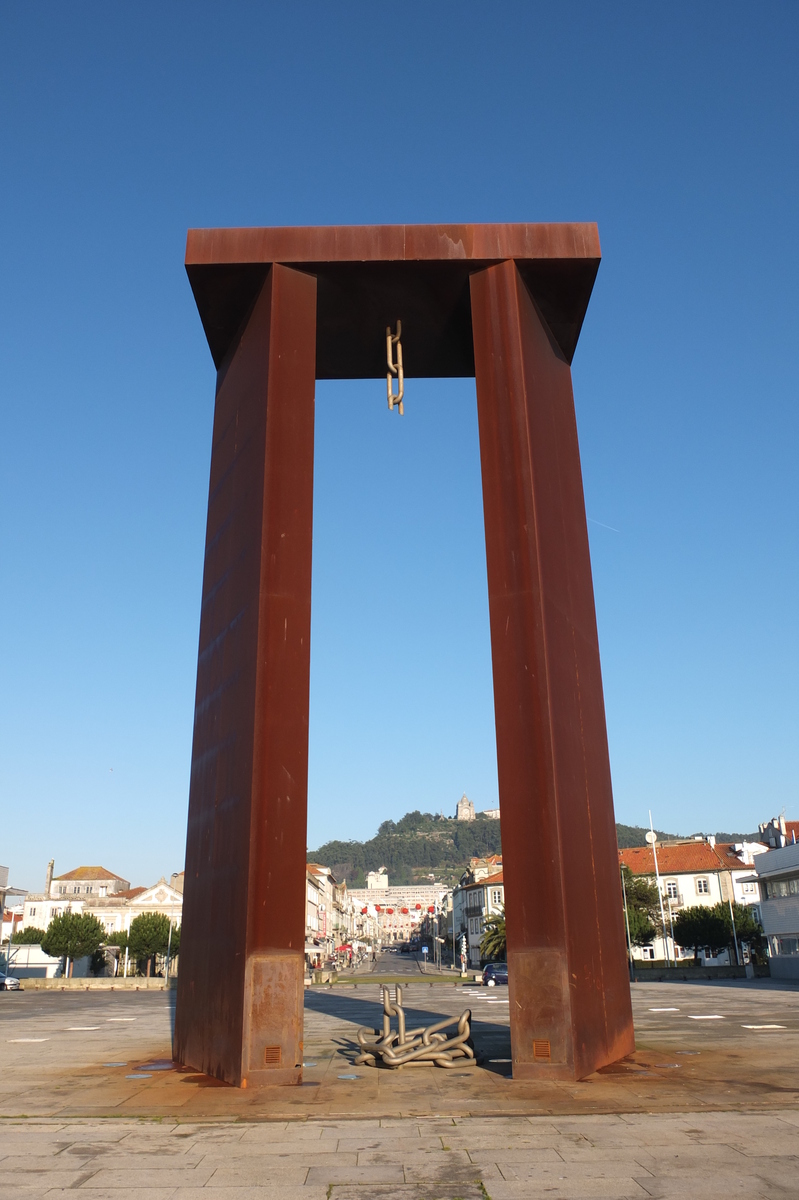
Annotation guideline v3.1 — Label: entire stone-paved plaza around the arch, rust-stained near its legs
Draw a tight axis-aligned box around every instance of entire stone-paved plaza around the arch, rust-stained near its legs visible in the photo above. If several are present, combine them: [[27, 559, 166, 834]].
[[0, 974, 799, 1200]]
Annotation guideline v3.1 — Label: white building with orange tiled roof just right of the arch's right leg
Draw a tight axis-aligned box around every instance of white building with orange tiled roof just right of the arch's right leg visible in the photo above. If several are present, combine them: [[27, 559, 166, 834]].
[[619, 835, 768, 966]]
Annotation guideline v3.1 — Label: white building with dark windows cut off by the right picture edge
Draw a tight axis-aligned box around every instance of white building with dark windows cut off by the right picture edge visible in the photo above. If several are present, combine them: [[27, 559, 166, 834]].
[[755, 840, 799, 979]]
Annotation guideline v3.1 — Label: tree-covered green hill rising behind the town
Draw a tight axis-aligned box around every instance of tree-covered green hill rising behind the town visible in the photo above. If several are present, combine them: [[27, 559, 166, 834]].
[[308, 810, 755, 888]]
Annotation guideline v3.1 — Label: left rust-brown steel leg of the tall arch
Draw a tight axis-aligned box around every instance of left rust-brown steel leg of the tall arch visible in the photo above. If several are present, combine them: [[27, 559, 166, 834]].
[[174, 265, 317, 1087]]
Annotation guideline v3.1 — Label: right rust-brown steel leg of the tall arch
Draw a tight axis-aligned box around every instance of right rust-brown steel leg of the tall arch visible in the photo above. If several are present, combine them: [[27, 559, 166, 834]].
[[470, 262, 635, 1079]]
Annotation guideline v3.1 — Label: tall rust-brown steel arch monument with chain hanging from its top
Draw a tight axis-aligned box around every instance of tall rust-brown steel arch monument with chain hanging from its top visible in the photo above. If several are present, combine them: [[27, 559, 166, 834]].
[[174, 224, 635, 1086]]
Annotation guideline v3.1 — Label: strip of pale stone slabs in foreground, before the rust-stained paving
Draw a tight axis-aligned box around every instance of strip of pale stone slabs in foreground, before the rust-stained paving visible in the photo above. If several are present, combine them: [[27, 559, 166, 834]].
[[0, 1110, 799, 1200]]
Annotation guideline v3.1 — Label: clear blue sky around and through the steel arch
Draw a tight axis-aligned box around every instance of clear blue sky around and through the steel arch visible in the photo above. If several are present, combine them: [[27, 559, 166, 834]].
[[0, 0, 799, 888]]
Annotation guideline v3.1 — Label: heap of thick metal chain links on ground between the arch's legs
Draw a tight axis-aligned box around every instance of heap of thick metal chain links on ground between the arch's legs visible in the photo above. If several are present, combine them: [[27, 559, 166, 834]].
[[355, 984, 475, 1069]]
